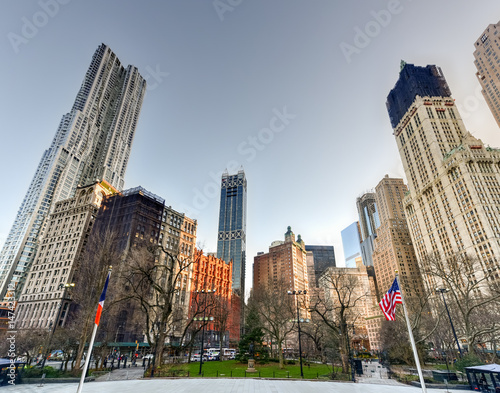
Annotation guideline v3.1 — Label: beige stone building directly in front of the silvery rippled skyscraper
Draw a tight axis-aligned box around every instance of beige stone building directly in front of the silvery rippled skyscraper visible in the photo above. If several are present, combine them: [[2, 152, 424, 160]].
[[16, 181, 116, 329]]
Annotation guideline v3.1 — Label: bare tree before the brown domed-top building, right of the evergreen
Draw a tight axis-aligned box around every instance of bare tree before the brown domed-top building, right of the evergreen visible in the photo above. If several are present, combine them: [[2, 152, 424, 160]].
[[255, 281, 296, 368]]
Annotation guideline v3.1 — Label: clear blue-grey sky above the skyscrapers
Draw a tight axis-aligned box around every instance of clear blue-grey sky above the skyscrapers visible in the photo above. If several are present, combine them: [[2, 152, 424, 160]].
[[0, 0, 500, 296]]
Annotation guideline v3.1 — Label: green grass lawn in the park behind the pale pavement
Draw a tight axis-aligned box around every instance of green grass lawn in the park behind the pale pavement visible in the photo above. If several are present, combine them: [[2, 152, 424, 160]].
[[155, 360, 348, 379]]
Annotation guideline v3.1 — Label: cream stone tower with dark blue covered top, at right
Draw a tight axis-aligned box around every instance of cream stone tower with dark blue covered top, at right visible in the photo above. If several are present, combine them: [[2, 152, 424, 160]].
[[387, 62, 500, 291]]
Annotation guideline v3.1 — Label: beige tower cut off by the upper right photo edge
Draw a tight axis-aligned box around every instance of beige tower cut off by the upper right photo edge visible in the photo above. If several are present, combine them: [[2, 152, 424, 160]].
[[474, 22, 500, 127]]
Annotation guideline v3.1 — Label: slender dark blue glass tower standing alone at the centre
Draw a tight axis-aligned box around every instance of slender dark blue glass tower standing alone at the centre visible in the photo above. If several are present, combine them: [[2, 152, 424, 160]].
[[217, 170, 247, 297]]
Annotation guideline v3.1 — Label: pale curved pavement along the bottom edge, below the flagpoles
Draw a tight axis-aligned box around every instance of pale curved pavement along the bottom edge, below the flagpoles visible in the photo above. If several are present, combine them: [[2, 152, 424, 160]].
[[6, 378, 464, 393]]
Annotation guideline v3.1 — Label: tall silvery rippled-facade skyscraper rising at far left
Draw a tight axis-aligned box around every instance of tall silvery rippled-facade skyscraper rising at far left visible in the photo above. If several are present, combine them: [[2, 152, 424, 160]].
[[0, 44, 146, 297]]
